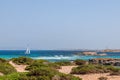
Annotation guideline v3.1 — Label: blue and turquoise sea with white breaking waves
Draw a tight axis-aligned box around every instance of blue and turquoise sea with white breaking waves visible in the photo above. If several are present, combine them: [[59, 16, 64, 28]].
[[0, 50, 120, 62]]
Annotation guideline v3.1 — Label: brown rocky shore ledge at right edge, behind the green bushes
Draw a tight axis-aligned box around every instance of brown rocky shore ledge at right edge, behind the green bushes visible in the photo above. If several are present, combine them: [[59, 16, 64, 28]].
[[89, 58, 120, 66]]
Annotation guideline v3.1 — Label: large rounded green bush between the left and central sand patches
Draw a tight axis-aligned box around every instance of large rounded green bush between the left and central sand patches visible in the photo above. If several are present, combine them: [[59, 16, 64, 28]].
[[27, 64, 81, 80]]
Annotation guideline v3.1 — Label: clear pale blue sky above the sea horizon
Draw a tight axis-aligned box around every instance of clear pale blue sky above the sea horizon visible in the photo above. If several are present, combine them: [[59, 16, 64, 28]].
[[0, 0, 120, 50]]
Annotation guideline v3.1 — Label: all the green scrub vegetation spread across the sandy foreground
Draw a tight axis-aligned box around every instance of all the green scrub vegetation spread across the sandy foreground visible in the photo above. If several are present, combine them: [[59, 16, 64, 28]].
[[0, 57, 120, 80]]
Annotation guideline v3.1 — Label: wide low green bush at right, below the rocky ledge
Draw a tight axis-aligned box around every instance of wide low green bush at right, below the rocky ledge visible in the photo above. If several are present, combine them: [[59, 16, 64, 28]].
[[71, 64, 120, 74]]
